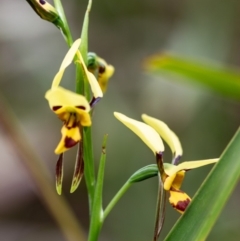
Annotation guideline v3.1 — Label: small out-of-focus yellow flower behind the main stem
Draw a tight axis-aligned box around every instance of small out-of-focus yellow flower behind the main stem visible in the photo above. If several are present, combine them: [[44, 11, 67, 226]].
[[88, 53, 115, 93]]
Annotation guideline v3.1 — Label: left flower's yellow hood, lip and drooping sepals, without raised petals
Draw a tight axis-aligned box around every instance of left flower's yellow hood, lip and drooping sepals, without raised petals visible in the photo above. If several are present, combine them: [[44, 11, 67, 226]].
[[45, 86, 91, 195]]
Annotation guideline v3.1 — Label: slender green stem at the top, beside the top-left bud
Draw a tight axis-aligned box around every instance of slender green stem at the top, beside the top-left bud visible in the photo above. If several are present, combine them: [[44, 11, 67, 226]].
[[53, 0, 73, 47]]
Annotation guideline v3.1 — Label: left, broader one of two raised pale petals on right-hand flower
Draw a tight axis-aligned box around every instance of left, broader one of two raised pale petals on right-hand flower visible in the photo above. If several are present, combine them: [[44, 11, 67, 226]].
[[114, 112, 164, 155]]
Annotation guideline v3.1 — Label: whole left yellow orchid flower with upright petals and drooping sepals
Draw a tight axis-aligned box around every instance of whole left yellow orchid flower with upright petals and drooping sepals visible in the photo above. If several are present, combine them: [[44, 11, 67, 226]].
[[45, 39, 103, 194]]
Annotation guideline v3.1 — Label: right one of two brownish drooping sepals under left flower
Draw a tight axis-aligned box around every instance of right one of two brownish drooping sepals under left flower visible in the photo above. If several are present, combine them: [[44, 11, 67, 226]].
[[70, 142, 84, 193]]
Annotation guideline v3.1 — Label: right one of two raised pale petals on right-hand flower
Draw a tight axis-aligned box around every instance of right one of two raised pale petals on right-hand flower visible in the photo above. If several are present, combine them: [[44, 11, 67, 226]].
[[142, 114, 183, 157]]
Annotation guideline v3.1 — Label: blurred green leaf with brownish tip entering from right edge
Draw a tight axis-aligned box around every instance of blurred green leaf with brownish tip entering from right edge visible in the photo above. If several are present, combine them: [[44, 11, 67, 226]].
[[145, 54, 240, 100]]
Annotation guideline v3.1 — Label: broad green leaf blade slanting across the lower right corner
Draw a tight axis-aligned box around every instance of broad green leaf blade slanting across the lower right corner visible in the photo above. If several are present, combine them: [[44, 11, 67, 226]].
[[165, 129, 240, 241]]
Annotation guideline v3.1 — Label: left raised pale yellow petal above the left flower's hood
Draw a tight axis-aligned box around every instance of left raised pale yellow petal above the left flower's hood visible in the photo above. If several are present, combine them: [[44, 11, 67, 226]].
[[52, 39, 81, 88]]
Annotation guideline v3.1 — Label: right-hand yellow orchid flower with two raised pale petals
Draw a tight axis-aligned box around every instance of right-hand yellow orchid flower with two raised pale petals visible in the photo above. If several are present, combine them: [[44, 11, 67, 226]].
[[114, 112, 219, 213]]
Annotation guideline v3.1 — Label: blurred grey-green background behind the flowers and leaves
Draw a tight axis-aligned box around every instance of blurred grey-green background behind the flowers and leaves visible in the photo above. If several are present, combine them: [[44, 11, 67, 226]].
[[0, 0, 240, 241]]
